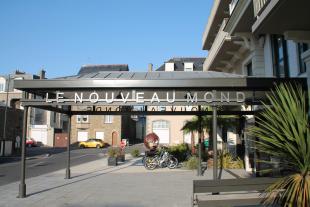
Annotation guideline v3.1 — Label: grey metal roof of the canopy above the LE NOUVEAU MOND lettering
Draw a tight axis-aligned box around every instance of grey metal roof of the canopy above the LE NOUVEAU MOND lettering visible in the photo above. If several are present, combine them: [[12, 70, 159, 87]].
[[15, 71, 307, 93]]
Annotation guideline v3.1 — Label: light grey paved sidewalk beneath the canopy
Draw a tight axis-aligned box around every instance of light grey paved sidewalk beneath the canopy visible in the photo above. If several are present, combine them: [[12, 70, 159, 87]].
[[0, 155, 249, 207]]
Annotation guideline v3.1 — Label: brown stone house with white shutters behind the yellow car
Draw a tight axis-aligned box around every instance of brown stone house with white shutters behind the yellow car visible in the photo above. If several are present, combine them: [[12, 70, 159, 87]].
[[71, 64, 136, 146]]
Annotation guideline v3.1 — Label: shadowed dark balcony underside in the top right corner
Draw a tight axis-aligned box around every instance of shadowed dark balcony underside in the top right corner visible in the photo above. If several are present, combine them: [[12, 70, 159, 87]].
[[252, 0, 310, 35]]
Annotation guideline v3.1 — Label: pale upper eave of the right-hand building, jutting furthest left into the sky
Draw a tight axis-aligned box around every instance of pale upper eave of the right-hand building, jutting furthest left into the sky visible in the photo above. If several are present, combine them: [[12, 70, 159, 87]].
[[202, 0, 231, 50]]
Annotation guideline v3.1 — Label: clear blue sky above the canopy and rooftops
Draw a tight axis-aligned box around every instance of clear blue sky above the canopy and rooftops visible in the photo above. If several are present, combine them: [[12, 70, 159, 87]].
[[0, 0, 213, 78]]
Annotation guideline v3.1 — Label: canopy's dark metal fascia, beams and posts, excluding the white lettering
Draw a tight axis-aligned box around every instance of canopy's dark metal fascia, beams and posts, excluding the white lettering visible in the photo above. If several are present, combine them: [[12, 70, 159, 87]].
[[14, 77, 307, 198]]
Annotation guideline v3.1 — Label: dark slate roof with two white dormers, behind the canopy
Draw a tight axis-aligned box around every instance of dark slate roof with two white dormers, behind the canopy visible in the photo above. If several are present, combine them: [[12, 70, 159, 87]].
[[156, 57, 206, 71]]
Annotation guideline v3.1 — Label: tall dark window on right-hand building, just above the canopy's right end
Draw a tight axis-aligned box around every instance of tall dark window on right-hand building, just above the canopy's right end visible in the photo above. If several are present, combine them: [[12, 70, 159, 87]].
[[272, 35, 289, 78]]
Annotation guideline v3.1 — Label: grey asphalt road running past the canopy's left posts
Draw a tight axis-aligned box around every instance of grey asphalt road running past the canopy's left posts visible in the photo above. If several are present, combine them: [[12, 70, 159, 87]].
[[0, 147, 107, 186]]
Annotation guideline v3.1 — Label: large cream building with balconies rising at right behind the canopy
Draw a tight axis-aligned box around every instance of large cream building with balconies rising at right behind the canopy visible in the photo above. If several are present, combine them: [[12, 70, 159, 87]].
[[202, 0, 310, 171]]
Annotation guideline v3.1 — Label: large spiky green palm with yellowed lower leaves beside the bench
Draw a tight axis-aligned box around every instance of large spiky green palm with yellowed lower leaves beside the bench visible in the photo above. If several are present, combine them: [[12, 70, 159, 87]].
[[250, 84, 310, 206]]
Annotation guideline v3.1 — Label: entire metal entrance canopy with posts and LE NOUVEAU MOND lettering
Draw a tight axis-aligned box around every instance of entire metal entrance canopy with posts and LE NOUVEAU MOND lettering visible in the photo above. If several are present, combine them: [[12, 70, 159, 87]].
[[14, 71, 307, 198]]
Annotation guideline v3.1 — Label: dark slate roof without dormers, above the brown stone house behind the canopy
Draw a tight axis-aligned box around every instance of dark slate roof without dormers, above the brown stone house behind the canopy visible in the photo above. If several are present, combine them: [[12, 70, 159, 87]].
[[78, 64, 129, 75]]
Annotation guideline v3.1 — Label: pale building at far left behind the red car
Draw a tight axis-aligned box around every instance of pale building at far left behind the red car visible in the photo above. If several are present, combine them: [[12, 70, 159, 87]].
[[0, 70, 65, 154]]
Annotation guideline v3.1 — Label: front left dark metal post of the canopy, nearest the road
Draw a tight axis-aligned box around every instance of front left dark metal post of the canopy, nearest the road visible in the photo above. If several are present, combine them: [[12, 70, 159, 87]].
[[18, 106, 28, 198]]
